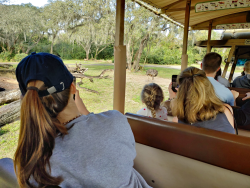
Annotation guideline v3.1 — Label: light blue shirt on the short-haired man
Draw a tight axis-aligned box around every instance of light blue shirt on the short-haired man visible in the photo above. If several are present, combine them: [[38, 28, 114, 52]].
[[207, 77, 234, 106]]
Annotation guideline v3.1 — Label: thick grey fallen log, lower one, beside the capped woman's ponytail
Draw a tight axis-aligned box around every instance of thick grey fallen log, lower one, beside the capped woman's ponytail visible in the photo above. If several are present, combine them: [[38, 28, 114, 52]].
[[0, 100, 21, 127]]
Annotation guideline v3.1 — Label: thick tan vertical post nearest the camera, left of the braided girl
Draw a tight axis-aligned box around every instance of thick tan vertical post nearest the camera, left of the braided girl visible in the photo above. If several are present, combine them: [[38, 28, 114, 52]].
[[113, 0, 126, 113]]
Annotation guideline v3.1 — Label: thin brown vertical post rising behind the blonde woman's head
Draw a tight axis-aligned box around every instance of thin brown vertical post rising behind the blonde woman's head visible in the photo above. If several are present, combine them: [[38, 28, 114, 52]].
[[181, 0, 191, 71]]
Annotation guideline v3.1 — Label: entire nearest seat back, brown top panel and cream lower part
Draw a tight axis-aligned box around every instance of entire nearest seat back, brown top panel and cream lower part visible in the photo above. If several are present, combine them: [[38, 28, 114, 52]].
[[126, 113, 250, 188]]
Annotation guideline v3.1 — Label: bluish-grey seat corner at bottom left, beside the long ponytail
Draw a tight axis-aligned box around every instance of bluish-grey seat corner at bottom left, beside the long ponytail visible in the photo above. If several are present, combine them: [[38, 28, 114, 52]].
[[0, 158, 19, 188]]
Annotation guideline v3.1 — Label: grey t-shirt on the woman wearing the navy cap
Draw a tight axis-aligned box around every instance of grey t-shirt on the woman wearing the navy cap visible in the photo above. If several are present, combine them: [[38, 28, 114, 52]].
[[50, 111, 150, 188]]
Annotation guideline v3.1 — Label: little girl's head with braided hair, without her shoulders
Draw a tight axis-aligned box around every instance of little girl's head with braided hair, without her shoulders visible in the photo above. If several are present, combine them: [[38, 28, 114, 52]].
[[141, 83, 164, 118]]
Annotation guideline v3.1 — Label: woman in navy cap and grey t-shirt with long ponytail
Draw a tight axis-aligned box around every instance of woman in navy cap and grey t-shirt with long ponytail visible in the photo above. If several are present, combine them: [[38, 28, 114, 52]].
[[14, 53, 149, 188]]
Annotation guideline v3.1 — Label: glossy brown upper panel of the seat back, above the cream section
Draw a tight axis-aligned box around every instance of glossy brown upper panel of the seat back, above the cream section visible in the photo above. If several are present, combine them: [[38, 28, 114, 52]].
[[126, 113, 250, 176]]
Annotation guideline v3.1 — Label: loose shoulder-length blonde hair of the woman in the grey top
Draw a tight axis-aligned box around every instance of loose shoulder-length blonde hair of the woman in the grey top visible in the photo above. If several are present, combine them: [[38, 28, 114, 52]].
[[171, 67, 224, 123]]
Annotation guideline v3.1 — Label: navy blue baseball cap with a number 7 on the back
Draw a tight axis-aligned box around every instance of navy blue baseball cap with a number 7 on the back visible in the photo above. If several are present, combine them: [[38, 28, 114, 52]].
[[16, 52, 73, 97]]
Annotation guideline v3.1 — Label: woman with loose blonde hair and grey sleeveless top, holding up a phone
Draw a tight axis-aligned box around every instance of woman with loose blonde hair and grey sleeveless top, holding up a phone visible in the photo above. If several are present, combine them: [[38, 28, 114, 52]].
[[170, 67, 235, 134]]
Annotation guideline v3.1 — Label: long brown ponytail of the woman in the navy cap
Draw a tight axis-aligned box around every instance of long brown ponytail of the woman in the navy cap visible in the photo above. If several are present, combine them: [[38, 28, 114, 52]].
[[14, 81, 70, 188]]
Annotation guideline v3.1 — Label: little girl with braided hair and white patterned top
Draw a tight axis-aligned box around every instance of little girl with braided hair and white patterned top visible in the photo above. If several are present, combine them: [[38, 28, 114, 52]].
[[137, 83, 168, 120]]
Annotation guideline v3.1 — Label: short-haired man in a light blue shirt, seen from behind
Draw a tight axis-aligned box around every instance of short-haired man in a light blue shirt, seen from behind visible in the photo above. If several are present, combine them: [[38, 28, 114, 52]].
[[201, 52, 239, 106]]
